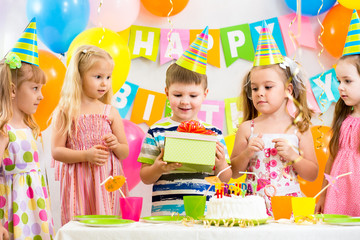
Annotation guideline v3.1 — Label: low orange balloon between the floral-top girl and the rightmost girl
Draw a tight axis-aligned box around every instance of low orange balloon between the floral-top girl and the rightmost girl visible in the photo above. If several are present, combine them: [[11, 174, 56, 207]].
[[298, 126, 331, 200]]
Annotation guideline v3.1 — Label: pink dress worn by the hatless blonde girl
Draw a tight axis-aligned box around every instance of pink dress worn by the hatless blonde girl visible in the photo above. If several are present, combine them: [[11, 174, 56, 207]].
[[55, 105, 128, 224]]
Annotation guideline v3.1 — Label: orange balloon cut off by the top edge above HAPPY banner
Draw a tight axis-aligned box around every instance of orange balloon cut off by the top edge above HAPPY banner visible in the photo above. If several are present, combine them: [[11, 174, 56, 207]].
[[141, 0, 189, 17]]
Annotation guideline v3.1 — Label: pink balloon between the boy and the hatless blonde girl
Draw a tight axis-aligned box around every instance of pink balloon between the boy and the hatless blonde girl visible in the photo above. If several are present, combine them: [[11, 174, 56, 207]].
[[122, 119, 145, 190]]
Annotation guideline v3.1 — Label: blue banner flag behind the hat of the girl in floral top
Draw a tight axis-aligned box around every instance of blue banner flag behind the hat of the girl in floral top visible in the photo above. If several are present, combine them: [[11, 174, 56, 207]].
[[249, 18, 286, 56]]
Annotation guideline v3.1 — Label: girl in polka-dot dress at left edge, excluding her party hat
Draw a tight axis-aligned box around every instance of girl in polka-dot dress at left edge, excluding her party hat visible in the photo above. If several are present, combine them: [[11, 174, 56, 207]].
[[0, 53, 54, 240]]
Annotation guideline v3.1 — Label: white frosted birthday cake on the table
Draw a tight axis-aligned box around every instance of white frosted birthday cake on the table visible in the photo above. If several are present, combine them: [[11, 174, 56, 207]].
[[205, 195, 269, 220]]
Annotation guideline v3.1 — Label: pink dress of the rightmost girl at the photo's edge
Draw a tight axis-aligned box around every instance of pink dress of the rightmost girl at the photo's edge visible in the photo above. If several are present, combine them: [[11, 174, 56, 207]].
[[324, 115, 360, 216]]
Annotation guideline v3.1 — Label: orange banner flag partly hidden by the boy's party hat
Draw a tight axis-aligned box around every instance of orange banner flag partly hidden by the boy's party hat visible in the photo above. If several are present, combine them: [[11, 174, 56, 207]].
[[190, 29, 220, 68]]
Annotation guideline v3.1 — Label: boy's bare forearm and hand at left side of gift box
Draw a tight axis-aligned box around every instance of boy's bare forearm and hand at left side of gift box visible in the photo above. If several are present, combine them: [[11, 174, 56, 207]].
[[140, 149, 182, 184]]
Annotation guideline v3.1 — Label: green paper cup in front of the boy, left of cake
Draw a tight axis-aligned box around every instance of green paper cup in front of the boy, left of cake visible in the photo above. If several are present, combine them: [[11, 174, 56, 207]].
[[183, 195, 206, 220]]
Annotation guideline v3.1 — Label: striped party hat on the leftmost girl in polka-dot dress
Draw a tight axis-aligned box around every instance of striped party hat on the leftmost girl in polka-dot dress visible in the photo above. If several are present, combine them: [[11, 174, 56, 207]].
[[8, 18, 39, 66]]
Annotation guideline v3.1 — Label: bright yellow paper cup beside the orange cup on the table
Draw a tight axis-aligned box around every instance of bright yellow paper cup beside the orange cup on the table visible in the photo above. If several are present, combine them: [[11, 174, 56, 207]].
[[291, 197, 316, 222]]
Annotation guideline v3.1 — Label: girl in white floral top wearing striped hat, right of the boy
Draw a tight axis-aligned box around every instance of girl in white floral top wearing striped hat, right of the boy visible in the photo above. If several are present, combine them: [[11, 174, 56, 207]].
[[231, 23, 318, 214]]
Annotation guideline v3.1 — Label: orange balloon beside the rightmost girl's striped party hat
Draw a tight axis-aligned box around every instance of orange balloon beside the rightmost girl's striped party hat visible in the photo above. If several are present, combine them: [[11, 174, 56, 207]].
[[321, 4, 353, 58]]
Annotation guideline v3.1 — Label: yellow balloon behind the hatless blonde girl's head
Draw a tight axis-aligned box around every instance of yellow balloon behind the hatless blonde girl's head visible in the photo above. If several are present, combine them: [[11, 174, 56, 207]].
[[67, 28, 131, 93]]
